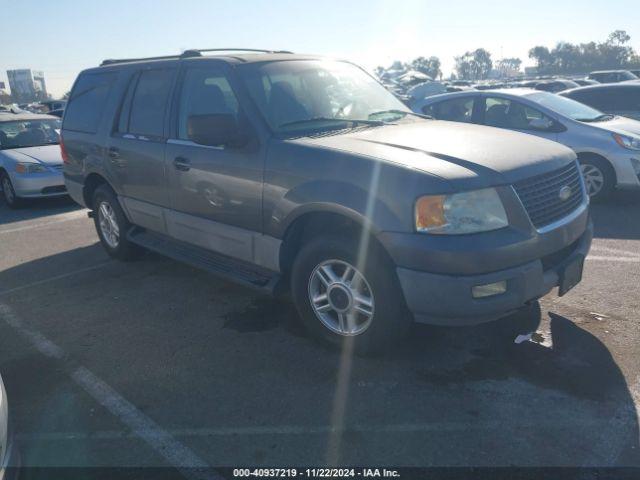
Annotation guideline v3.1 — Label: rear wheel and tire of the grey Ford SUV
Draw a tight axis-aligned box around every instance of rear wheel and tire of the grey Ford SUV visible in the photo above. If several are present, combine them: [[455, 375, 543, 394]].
[[92, 185, 142, 261]]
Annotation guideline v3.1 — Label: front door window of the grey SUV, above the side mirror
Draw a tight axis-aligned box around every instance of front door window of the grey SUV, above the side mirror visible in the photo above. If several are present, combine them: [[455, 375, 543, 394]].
[[178, 67, 238, 140]]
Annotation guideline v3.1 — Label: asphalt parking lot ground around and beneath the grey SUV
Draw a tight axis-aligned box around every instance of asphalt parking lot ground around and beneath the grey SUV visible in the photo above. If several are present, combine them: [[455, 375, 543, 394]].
[[0, 193, 640, 476]]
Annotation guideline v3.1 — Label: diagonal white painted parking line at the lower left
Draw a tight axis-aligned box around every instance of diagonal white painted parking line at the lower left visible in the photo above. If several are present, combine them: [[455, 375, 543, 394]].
[[0, 303, 221, 480]]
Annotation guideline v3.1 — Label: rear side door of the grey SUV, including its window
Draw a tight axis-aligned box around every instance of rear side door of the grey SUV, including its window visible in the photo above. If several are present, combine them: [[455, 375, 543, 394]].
[[107, 67, 177, 232]]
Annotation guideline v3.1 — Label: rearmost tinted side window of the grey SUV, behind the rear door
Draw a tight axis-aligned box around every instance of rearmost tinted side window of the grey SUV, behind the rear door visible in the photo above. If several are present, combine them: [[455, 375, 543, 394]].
[[63, 72, 117, 133]]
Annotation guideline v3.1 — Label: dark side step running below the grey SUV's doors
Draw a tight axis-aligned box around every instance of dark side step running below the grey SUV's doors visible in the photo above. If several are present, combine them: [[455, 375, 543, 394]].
[[127, 227, 280, 295]]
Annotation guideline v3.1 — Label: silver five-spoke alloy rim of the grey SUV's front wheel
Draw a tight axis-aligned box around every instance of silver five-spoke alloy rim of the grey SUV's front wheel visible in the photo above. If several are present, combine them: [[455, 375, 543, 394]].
[[308, 260, 375, 336]]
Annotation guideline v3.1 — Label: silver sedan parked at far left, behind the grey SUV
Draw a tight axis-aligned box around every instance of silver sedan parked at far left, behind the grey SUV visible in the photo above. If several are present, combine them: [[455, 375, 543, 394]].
[[0, 113, 67, 208]]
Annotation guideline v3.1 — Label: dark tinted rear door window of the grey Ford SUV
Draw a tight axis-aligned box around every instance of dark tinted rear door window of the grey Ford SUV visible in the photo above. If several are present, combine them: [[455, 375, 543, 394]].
[[127, 69, 174, 137]]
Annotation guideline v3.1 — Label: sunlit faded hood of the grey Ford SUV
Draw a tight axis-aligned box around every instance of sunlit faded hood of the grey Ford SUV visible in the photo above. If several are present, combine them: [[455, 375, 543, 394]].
[[296, 120, 576, 189]]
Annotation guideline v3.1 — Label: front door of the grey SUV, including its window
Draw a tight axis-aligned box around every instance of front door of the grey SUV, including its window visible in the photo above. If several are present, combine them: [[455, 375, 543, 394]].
[[166, 63, 263, 260]]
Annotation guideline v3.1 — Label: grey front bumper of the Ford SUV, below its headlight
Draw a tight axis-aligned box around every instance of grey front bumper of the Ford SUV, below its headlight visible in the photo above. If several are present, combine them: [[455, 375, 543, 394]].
[[397, 220, 593, 325]]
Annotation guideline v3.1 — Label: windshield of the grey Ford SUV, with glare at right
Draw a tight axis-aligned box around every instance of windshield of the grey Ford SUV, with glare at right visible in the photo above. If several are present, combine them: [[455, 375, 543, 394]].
[[239, 60, 415, 134]]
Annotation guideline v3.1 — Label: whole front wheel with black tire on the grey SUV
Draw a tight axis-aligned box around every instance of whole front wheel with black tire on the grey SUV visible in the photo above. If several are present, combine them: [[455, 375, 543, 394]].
[[291, 235, 411, 354]]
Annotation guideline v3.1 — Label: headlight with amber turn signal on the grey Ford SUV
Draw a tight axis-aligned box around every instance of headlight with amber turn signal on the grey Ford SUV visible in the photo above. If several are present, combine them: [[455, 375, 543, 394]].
[[415, 188, 509, 235]]
